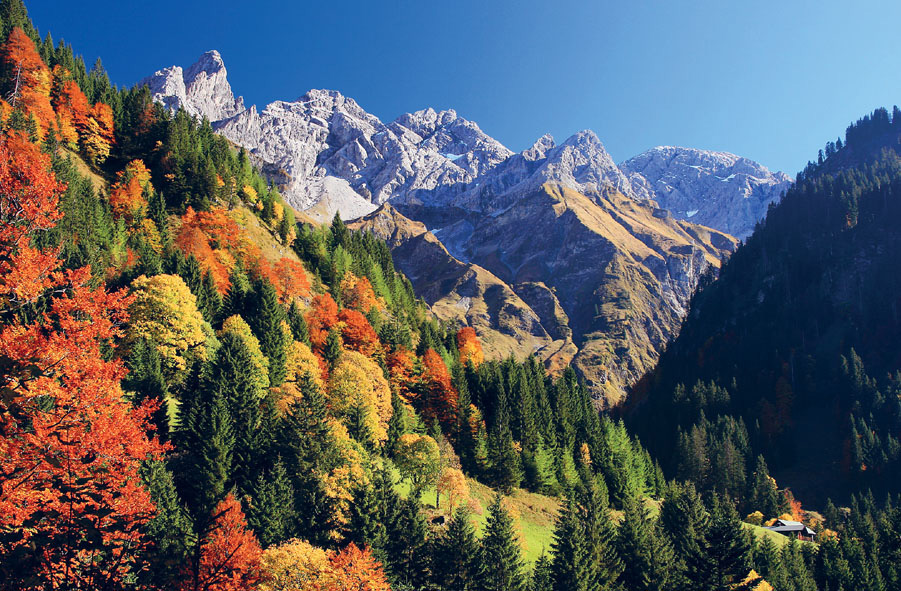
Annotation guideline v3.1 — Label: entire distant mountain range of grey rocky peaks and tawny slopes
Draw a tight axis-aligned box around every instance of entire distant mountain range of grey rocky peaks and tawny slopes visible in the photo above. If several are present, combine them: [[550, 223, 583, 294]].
[[141, 51, 791, 404]]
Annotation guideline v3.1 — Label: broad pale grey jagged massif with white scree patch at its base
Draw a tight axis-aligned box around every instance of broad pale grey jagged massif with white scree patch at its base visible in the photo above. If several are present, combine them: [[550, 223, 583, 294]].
[[214, 97, 510, 219]]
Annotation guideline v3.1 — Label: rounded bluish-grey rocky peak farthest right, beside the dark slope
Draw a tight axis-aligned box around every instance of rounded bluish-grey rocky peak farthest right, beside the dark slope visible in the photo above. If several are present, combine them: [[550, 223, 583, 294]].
[[620, 146, 792, 238]]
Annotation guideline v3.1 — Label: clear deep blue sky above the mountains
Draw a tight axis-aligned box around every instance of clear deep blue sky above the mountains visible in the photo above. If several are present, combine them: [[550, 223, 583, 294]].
[[26, 0, 901, 175]]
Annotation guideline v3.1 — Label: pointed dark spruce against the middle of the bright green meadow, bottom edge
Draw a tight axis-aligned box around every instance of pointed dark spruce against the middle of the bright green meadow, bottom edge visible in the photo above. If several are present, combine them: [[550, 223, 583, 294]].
[[478, 494, 526, 591]]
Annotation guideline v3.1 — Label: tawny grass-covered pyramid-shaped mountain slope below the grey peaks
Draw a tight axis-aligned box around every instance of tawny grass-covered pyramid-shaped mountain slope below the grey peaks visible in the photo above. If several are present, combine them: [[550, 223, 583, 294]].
[[404, 184, 736, 404]]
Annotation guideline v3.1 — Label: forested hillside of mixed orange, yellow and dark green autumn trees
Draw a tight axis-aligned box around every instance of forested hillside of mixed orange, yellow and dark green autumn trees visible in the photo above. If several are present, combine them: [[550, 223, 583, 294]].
[[0, 0, 901, 591]]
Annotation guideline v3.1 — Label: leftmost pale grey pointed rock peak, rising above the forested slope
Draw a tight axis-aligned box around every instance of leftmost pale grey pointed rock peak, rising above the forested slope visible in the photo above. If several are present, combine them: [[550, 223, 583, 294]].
[[138, 51, 244, 121]]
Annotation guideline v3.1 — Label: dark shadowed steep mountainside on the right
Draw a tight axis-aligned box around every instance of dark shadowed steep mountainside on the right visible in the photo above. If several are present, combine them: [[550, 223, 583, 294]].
[[632, 110, 901, 502]]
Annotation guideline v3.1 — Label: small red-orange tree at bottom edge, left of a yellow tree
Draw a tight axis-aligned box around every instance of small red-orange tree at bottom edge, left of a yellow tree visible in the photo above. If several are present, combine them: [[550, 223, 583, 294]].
[[187, 493, 263, 591]]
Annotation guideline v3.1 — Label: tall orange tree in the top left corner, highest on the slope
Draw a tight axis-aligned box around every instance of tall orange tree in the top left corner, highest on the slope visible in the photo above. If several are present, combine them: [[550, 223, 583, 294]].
[[3, 27, 56, 139]]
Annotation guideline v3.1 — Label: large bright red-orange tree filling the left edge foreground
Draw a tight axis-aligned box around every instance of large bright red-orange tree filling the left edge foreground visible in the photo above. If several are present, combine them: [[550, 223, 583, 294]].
[[0, 135, 164, 589]]
